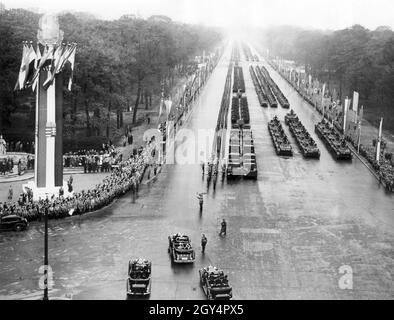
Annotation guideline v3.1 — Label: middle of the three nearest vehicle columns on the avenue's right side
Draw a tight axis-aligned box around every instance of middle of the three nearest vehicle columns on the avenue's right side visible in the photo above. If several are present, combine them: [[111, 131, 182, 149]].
[[285, 109, 320, 159]]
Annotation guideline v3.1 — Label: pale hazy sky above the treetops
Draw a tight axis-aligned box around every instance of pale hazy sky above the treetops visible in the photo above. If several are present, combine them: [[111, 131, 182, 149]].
[[0, 0, 394, 29]]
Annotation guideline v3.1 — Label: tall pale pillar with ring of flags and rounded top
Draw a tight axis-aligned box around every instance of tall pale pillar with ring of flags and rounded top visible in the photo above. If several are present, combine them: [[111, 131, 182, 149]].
[[19, 14, 76, 200]]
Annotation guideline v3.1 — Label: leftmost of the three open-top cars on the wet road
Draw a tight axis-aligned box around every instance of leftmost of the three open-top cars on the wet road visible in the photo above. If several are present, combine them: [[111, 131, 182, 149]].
[[126, 258, 152, 296]]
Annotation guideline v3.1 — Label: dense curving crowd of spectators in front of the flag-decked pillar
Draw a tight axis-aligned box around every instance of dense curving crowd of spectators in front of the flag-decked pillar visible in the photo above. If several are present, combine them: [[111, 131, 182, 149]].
[[0, 143, 159, 221]]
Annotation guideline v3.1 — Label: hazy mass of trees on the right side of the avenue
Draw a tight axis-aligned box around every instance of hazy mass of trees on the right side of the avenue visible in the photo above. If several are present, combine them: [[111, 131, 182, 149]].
[[263, 25, 394, 130]]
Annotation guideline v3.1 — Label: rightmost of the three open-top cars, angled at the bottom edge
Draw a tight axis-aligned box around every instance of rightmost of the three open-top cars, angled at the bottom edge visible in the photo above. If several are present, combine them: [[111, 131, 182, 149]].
[[199, 266, 233, 300]]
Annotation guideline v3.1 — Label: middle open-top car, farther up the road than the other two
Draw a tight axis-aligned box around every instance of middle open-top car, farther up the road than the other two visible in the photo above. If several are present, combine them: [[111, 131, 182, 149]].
[[168, 233, 196, 263]]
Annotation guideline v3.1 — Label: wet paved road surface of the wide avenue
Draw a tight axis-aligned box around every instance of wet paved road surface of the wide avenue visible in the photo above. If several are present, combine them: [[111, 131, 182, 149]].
[[0, 43, 394, 299]]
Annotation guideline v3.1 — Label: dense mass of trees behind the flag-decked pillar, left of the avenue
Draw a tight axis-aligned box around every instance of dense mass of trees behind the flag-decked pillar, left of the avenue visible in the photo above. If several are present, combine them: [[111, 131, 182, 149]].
[[0, 9, 221, 141]]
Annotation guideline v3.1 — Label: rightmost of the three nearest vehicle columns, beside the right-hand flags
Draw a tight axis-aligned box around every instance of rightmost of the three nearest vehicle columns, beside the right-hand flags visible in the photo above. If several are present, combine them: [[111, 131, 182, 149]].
[[315, 119, 352, 160]]
